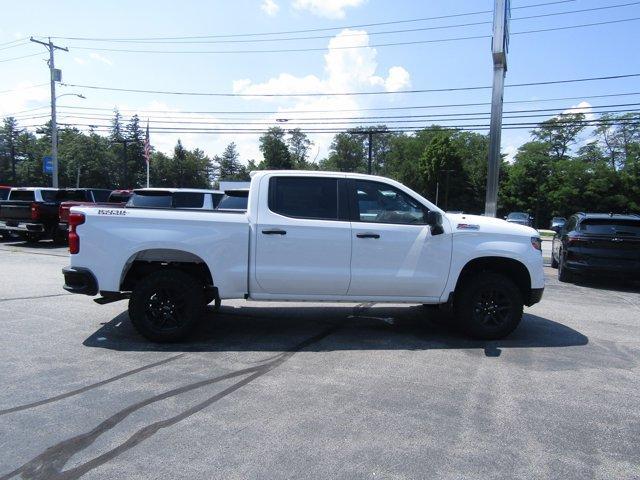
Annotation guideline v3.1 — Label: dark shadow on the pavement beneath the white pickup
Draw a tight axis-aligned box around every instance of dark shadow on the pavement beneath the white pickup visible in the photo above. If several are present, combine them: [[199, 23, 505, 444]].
[[83, 303, 589, 356]]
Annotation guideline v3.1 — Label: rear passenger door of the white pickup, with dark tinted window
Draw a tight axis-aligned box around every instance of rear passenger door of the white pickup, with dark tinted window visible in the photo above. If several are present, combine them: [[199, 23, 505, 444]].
[[254, 175, 351, 296]]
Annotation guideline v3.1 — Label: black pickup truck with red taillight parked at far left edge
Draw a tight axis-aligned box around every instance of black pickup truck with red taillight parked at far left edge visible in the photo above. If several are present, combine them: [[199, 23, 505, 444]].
[[0, 187, 111, 242]]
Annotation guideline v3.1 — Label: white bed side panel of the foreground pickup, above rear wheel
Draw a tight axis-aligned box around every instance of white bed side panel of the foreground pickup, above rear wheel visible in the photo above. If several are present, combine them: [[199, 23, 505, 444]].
[[71, 207, 249, 298]]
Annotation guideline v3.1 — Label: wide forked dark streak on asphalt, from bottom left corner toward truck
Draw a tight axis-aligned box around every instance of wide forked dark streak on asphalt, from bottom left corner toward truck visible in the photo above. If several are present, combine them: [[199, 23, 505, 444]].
[[0, 325, 340, 480]]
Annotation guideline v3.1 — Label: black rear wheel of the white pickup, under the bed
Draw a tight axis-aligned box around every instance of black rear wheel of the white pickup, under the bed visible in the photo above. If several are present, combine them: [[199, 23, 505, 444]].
[[129, 270, 204, 342]]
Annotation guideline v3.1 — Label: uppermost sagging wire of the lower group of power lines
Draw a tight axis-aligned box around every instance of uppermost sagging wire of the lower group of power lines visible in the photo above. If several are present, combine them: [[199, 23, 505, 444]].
[[62, 73, 640, 97]]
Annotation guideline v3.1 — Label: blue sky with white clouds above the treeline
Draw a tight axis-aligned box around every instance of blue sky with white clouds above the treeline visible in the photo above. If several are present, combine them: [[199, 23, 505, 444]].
[[0, 0, 640, 161]]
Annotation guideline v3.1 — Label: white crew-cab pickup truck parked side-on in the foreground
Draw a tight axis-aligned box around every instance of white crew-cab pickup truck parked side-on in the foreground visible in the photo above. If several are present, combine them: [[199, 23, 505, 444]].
[[63, 171, 544, 341]]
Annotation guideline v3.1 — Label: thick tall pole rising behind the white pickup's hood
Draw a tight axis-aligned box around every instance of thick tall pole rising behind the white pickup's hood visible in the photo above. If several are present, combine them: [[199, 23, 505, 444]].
[[484, 0, 511, 217]]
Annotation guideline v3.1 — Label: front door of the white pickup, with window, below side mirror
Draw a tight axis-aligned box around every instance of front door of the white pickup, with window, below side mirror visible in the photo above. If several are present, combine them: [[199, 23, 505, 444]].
[[348, 180, 451, 299]]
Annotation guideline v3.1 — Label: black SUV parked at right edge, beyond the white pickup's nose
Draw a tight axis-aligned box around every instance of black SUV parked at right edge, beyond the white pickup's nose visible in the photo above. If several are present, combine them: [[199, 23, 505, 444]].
[[551, 213, 640, 282]]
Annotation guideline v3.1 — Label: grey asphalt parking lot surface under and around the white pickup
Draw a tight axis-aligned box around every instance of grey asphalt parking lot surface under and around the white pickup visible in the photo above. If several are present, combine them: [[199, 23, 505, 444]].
[[0, 238, 640, 479]]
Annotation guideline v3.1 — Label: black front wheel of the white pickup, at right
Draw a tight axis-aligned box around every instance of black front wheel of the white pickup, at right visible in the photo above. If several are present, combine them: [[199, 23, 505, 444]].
[[455, 272, 524, 340]]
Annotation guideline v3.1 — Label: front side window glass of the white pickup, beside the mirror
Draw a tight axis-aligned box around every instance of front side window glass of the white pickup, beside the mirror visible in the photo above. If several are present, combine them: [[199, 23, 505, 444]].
[[355, 180, 426, 225]]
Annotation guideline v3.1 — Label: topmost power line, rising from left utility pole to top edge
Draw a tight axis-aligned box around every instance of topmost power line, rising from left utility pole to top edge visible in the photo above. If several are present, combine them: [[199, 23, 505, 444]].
[[42, 0, 576, 42]]
